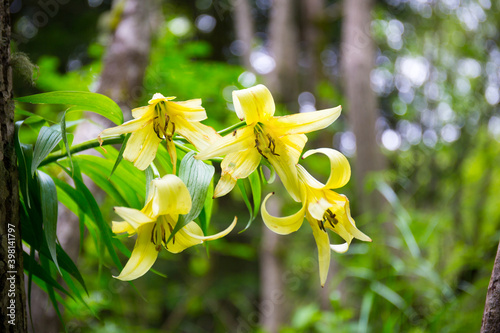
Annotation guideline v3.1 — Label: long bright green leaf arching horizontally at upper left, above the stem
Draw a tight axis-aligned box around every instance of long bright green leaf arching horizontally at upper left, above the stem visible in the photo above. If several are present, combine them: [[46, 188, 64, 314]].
[[16, 91, 123, 125]]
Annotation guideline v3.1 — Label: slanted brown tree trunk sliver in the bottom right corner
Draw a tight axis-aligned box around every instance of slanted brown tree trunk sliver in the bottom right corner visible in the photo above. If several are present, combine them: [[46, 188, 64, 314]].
[[481, 239, 500, 333]]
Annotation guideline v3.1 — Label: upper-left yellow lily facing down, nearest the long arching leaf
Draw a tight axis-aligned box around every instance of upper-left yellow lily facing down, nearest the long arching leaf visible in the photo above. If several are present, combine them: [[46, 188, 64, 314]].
[[98, 93, 220, 173]]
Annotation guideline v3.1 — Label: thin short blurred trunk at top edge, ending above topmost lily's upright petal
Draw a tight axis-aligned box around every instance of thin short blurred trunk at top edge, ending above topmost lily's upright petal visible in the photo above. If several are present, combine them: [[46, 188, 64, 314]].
[[232, 0, 254, 71]]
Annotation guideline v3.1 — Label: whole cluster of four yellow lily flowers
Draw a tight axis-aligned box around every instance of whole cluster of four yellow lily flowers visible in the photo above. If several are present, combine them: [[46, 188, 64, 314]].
[[99, 85, 371, 286]]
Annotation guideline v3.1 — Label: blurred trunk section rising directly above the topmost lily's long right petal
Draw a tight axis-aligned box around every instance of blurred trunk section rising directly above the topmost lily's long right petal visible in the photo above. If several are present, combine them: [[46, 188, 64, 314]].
[[267, 0, 299, 111]]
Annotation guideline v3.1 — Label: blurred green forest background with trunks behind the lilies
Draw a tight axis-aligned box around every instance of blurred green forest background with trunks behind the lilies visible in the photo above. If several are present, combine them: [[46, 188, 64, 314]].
[[11, 0, 500, 333]]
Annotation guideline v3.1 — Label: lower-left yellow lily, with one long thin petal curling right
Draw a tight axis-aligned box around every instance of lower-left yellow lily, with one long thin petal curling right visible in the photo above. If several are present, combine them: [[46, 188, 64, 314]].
[[112, 175, 237, 281]]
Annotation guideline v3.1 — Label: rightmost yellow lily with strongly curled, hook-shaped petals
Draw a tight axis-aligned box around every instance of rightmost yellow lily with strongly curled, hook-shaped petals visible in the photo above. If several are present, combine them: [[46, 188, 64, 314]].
[[262, 148, 371, 286]]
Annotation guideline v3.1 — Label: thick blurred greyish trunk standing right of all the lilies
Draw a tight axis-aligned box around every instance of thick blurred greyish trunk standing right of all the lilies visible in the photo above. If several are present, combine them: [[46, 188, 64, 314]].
[[341, 0, 386, 212]]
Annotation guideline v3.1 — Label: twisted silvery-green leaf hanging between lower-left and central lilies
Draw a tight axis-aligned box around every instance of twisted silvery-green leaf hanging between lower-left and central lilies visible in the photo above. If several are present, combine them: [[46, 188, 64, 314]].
[[166, 152, 215, 244]]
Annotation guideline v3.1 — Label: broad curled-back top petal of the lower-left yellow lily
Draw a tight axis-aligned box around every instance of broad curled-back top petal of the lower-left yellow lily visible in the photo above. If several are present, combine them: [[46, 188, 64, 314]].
[[142, 175, 191, 217]]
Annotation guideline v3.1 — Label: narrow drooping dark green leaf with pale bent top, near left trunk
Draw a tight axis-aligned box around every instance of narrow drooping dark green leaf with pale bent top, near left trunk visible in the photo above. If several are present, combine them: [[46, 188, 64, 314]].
[[37, 170, 61, 272]]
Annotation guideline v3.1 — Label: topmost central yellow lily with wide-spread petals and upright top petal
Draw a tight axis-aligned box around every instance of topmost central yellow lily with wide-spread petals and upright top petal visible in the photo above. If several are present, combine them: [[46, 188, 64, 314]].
[[196, 84, 341, 201]]
